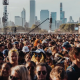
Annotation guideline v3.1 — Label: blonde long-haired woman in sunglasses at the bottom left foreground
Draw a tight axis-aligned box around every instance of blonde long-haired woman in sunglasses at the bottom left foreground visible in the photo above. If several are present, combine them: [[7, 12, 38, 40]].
[[9, 65, 31, 80]]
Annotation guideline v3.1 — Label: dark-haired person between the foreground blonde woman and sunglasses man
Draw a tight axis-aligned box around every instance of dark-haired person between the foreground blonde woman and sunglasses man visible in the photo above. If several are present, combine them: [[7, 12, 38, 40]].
[[25, 61, 36, 80]]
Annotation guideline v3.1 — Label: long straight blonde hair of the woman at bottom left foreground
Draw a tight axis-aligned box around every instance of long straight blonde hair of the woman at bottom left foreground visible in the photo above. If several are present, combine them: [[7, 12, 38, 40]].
[[11, 65, 31, 80]]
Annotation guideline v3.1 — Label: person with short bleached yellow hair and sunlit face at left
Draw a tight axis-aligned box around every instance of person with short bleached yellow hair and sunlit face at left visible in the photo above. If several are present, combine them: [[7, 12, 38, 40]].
[[8, 48, 19, 67]]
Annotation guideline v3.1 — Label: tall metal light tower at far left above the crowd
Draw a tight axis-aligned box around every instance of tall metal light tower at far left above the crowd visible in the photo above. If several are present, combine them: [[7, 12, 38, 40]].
[[2, 0, 9, 34]]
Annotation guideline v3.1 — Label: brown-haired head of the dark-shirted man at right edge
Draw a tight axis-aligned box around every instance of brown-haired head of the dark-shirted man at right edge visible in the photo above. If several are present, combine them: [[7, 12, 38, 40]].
[[69, 47, 80, 63]]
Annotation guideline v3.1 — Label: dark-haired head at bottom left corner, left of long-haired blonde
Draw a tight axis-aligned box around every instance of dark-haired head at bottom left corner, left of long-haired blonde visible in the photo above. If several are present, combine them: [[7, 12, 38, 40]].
[[1, 63, 12, 78]]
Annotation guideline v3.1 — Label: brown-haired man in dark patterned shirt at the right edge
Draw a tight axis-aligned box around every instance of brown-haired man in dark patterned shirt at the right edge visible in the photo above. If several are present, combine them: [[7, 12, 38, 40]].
[[66, 47, 80, 80]]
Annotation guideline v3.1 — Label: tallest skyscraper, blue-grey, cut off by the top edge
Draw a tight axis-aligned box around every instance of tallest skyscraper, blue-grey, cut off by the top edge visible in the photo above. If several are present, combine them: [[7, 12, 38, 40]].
[[29, 0, 35, 27]]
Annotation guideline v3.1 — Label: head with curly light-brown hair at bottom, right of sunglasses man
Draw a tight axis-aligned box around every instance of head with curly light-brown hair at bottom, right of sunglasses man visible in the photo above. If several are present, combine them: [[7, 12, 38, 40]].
[[50, 66, 67, 80]]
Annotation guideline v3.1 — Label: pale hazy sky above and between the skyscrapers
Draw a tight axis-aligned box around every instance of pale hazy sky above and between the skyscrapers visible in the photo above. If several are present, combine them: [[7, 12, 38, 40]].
[[0, 0, 80, 21]]
